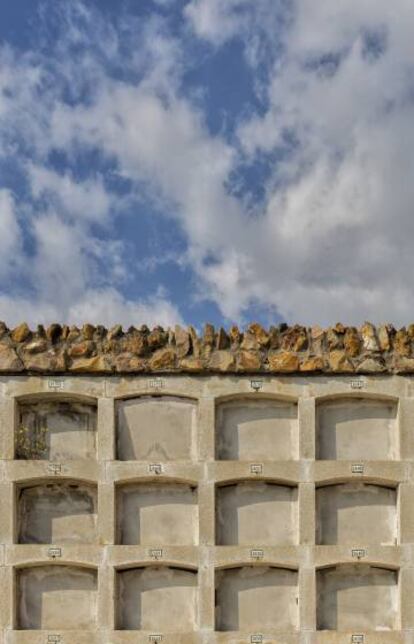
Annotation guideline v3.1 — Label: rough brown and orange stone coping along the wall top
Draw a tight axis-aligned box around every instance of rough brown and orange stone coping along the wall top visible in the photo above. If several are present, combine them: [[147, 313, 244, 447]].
[[0, 322, 414, 374]]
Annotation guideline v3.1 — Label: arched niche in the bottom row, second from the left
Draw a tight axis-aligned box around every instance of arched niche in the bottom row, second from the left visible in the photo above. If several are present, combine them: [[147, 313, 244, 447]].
[[117, 566, 198, 633]]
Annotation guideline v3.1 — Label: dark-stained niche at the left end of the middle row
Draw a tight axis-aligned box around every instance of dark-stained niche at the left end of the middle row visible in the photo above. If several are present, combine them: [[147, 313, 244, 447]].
[[17, 482, 97, 543]]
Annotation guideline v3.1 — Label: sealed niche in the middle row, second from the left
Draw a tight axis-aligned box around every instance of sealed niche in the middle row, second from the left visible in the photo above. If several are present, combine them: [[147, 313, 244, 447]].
[[117, 483, 198, 546]]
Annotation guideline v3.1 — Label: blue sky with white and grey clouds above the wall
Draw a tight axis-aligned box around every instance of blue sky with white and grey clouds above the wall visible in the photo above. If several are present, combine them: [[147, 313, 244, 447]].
[[0, 0, 414, 328]]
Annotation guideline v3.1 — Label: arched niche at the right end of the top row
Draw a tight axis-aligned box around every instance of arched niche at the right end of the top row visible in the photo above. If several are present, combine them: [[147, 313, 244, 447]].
[[317, 398, 398, 460]]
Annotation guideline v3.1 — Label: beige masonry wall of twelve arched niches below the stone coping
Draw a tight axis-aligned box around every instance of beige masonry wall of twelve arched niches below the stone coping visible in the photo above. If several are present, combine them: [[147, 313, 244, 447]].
[[0, 375, 414, 644]]
